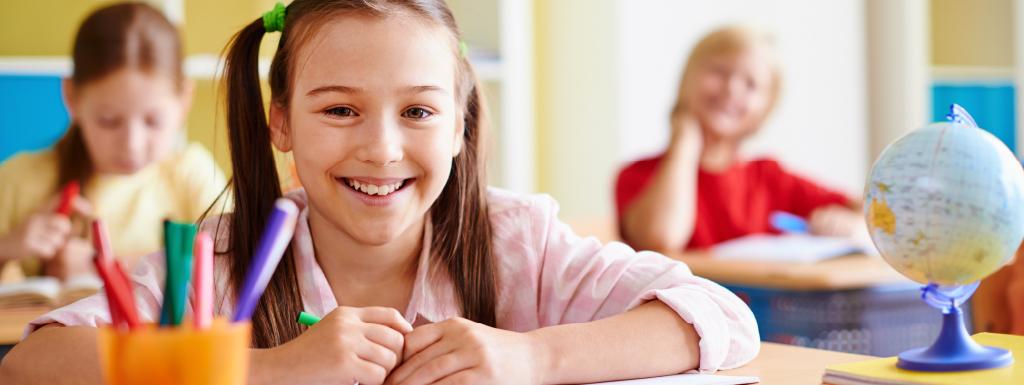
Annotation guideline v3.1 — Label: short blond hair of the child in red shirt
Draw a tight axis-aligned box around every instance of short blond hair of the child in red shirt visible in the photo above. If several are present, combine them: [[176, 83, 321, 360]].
[[671, 26, 782, 129]]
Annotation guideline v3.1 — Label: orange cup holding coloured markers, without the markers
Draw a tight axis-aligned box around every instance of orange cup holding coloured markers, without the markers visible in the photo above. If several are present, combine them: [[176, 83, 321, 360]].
[[98, 318, 250, 385]]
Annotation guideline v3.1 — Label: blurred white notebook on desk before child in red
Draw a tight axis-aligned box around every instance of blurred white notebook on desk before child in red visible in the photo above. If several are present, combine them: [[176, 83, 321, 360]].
[[711, 233, 874, 263]]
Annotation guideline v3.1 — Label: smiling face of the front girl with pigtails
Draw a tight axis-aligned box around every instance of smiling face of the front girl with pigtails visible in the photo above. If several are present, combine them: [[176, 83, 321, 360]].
[[270, 14, 463, 245]]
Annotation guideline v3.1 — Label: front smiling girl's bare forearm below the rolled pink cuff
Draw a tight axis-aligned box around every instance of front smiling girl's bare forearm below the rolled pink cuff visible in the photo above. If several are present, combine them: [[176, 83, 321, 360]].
[[527, 300, 700, 384]]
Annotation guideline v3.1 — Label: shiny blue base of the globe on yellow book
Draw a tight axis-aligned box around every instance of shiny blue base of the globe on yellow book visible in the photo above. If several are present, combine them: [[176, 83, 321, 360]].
[[896, 306, 1014, 372]]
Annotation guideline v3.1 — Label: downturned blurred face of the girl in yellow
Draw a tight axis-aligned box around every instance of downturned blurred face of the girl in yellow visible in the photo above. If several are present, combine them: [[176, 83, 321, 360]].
[[65, 70, 191, 175]]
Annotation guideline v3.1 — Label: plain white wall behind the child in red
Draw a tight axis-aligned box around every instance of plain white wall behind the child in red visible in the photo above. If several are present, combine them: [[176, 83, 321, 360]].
[[616, 0, 870, 196]]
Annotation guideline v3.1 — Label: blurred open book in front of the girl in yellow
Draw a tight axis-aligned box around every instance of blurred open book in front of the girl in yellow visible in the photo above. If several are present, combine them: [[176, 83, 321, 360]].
[[0, 275, 103, 309]]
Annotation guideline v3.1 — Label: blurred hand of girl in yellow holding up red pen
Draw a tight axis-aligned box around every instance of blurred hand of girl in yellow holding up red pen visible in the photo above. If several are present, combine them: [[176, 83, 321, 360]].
[[3, 195, 92, 259]]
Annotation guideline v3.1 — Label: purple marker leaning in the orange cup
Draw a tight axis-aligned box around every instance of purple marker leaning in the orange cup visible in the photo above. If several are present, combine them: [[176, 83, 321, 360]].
[[231, 198, 299, 323]]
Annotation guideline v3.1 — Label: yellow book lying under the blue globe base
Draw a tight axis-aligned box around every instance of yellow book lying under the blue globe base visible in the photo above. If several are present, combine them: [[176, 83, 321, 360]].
[[821, 333, 1024, 385]]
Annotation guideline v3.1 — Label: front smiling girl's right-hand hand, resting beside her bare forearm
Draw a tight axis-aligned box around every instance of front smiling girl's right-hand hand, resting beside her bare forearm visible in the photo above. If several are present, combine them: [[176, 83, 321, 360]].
[[387, 318, 546, 385]]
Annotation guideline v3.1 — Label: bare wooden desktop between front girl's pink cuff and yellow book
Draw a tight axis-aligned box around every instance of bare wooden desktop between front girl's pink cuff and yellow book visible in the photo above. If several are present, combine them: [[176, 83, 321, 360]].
[[719, 342, 876, 385]]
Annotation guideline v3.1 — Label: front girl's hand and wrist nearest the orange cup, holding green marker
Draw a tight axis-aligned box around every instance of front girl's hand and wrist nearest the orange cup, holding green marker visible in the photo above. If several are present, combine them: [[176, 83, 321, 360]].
[[253, 306, 413, 385]]
